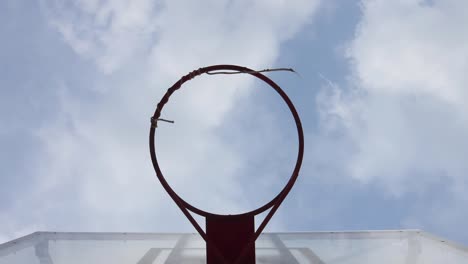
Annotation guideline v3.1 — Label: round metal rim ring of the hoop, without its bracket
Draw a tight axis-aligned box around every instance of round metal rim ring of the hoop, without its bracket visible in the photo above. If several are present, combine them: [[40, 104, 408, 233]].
[[149, 65, 304, 217]]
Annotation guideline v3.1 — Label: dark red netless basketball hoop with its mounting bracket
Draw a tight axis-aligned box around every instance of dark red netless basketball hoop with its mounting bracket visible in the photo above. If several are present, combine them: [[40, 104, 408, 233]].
[[149, 65, 304, 264]]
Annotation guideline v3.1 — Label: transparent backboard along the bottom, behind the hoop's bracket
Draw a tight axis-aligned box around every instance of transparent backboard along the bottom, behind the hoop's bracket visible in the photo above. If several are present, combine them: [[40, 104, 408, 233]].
[[0, 230, 468, 264]]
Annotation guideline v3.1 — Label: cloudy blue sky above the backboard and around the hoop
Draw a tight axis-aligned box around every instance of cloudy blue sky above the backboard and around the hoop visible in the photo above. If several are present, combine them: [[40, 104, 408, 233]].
[[0, 0, 468, 244]]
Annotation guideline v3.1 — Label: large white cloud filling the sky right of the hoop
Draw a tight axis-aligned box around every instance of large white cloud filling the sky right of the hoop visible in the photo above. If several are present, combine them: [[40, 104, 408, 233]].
[[318, 1, 468, 233]]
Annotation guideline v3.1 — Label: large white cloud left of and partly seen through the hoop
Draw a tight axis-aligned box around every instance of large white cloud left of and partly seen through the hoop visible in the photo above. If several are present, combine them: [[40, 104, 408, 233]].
[[0, 0, 318, 241]]
